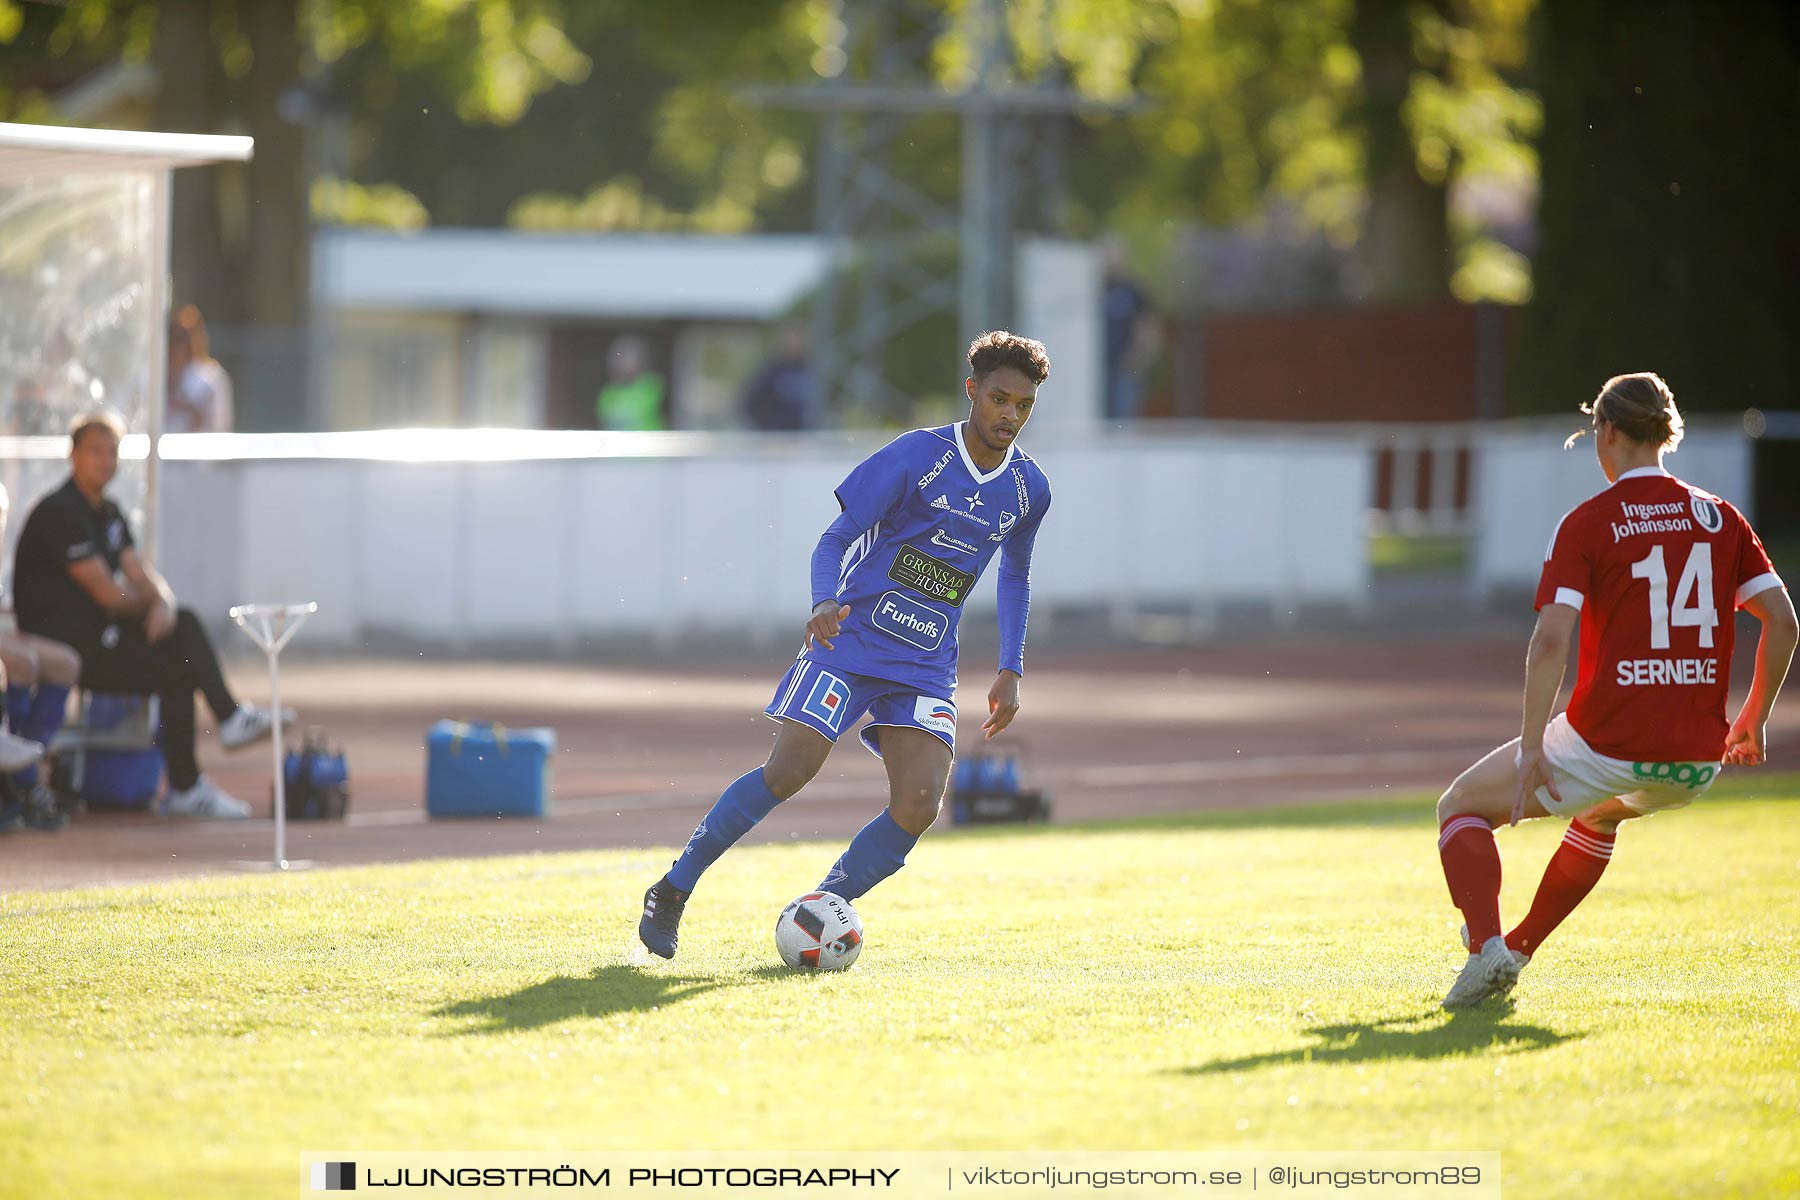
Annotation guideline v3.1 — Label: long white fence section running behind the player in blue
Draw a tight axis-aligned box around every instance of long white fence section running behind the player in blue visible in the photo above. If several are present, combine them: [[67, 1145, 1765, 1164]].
[[162, 430, 1370, 646]]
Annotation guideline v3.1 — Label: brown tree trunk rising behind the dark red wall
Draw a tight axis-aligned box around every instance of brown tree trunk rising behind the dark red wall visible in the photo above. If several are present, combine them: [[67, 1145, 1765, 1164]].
[[1350, 0, 1449, 300]]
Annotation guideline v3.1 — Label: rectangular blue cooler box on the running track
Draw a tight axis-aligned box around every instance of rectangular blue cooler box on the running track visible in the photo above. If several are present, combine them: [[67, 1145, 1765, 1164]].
[[425, 721, 556, 817]]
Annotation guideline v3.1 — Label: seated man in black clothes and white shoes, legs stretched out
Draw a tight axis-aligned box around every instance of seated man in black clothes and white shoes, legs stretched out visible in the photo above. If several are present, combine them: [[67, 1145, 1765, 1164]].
[[13, 412, 284, 817]]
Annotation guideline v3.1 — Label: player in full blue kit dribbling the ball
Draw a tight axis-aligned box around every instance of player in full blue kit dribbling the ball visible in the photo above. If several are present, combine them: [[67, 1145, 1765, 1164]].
[[637, 331, 1049, 959]]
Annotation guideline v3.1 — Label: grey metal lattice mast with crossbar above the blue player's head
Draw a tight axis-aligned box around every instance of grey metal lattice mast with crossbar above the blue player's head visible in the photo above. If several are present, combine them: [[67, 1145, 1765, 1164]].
[[747, 0, 1129, 417]]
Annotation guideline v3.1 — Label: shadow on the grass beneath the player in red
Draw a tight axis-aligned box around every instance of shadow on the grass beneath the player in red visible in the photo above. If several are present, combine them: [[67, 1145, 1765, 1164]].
[[1170, 1004, 1582, 1076]]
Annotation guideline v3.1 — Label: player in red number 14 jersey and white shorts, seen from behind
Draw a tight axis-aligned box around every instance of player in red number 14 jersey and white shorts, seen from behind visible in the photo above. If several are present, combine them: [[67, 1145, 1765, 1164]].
[[1438, 372, 1800, 1007]]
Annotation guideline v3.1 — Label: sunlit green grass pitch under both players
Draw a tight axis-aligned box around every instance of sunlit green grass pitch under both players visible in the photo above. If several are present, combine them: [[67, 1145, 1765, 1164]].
[[0, 775, 1800, 1198]]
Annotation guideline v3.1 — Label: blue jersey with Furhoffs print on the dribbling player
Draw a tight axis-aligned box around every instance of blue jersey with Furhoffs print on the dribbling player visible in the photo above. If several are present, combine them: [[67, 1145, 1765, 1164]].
[[803, 423, 1049, 696]]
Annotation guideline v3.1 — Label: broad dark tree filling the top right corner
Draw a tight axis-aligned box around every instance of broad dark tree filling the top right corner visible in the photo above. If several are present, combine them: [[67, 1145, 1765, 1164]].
[[1512, 0, 1800, 412]]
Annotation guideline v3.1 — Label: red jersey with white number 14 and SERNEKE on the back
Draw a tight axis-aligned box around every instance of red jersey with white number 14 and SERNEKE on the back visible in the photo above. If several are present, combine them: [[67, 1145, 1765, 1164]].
[[1537, 466, 1782, 763]]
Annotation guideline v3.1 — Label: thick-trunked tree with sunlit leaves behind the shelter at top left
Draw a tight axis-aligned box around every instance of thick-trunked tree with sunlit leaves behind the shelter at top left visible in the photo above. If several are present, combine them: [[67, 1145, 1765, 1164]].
[[0, 0, 589, 426]]
